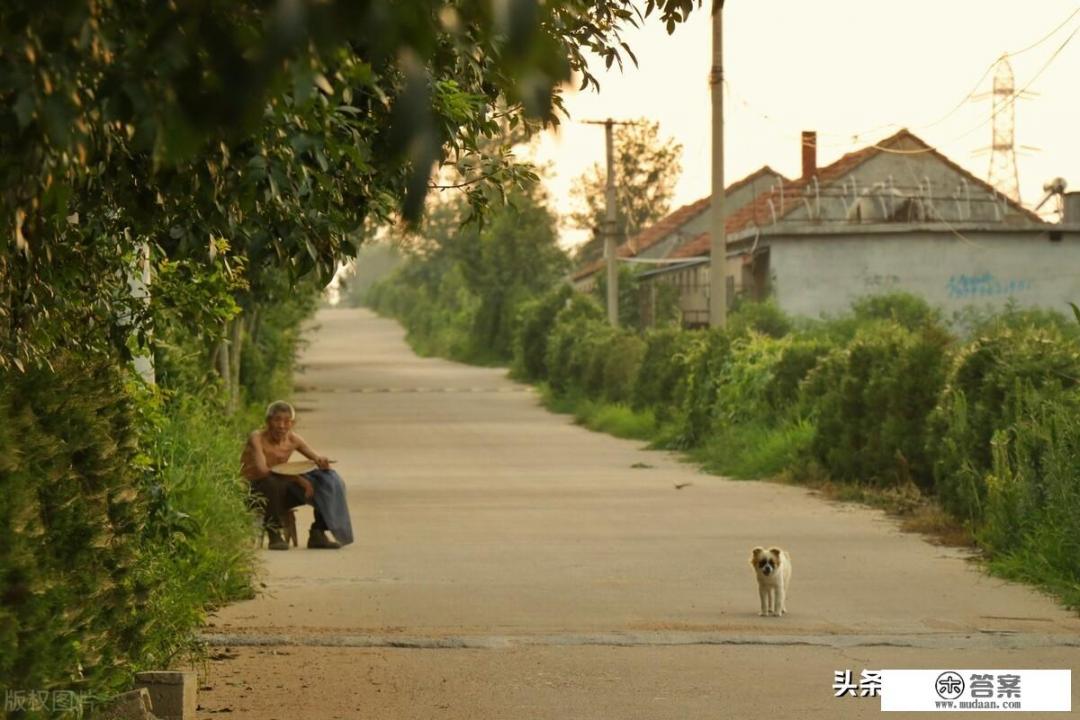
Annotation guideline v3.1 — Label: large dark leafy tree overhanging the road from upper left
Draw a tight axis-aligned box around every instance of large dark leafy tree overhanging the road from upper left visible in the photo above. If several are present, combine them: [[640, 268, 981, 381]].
[[0, 0, 699, 366]]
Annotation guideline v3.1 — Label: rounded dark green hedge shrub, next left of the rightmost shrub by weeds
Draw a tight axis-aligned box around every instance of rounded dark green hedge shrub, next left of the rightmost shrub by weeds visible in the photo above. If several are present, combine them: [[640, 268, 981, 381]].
[[802, 321, 949, 488]]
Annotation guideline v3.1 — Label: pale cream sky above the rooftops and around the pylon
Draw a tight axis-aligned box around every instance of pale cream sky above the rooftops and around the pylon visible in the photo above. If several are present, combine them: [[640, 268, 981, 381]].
[[535, 0, 1080, 244]]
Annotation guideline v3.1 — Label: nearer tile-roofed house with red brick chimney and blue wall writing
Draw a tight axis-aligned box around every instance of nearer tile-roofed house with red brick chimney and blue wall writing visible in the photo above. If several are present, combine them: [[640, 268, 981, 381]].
[[640, 130, 1080, 326]]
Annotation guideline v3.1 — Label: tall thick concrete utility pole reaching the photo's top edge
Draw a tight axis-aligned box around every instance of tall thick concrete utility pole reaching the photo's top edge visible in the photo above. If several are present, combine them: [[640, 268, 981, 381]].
[[708, 0, 728, 327]]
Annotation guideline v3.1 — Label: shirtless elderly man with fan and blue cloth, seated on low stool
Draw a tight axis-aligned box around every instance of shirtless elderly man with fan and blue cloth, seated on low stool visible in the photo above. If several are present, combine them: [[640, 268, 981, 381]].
[[240, 400, 352, 551]]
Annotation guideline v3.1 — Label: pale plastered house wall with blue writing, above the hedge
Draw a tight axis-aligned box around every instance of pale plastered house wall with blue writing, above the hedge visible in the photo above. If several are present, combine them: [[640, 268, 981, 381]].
[[768, 229, 1080, 317]]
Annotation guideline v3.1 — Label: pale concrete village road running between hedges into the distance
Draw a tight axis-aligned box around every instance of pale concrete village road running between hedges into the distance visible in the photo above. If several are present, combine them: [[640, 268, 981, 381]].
[[199, 310, 1080, 720]]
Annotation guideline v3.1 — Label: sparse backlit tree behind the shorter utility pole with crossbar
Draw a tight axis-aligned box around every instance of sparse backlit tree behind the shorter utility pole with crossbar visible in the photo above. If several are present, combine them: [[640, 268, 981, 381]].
[[569, 118, 683, 261]]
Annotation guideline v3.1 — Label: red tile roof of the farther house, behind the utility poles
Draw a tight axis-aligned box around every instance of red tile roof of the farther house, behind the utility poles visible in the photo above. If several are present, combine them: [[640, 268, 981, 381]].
[[571, 165, 788, 291]]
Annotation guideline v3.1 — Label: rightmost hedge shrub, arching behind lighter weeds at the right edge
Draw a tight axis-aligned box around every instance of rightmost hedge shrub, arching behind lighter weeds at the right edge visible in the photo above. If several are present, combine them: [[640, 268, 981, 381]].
[[928, 324, 1080, 524]]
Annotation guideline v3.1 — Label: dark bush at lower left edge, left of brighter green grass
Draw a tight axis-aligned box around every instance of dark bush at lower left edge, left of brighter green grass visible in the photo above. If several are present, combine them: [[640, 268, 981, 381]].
[[0, 357, 150, 692]]
